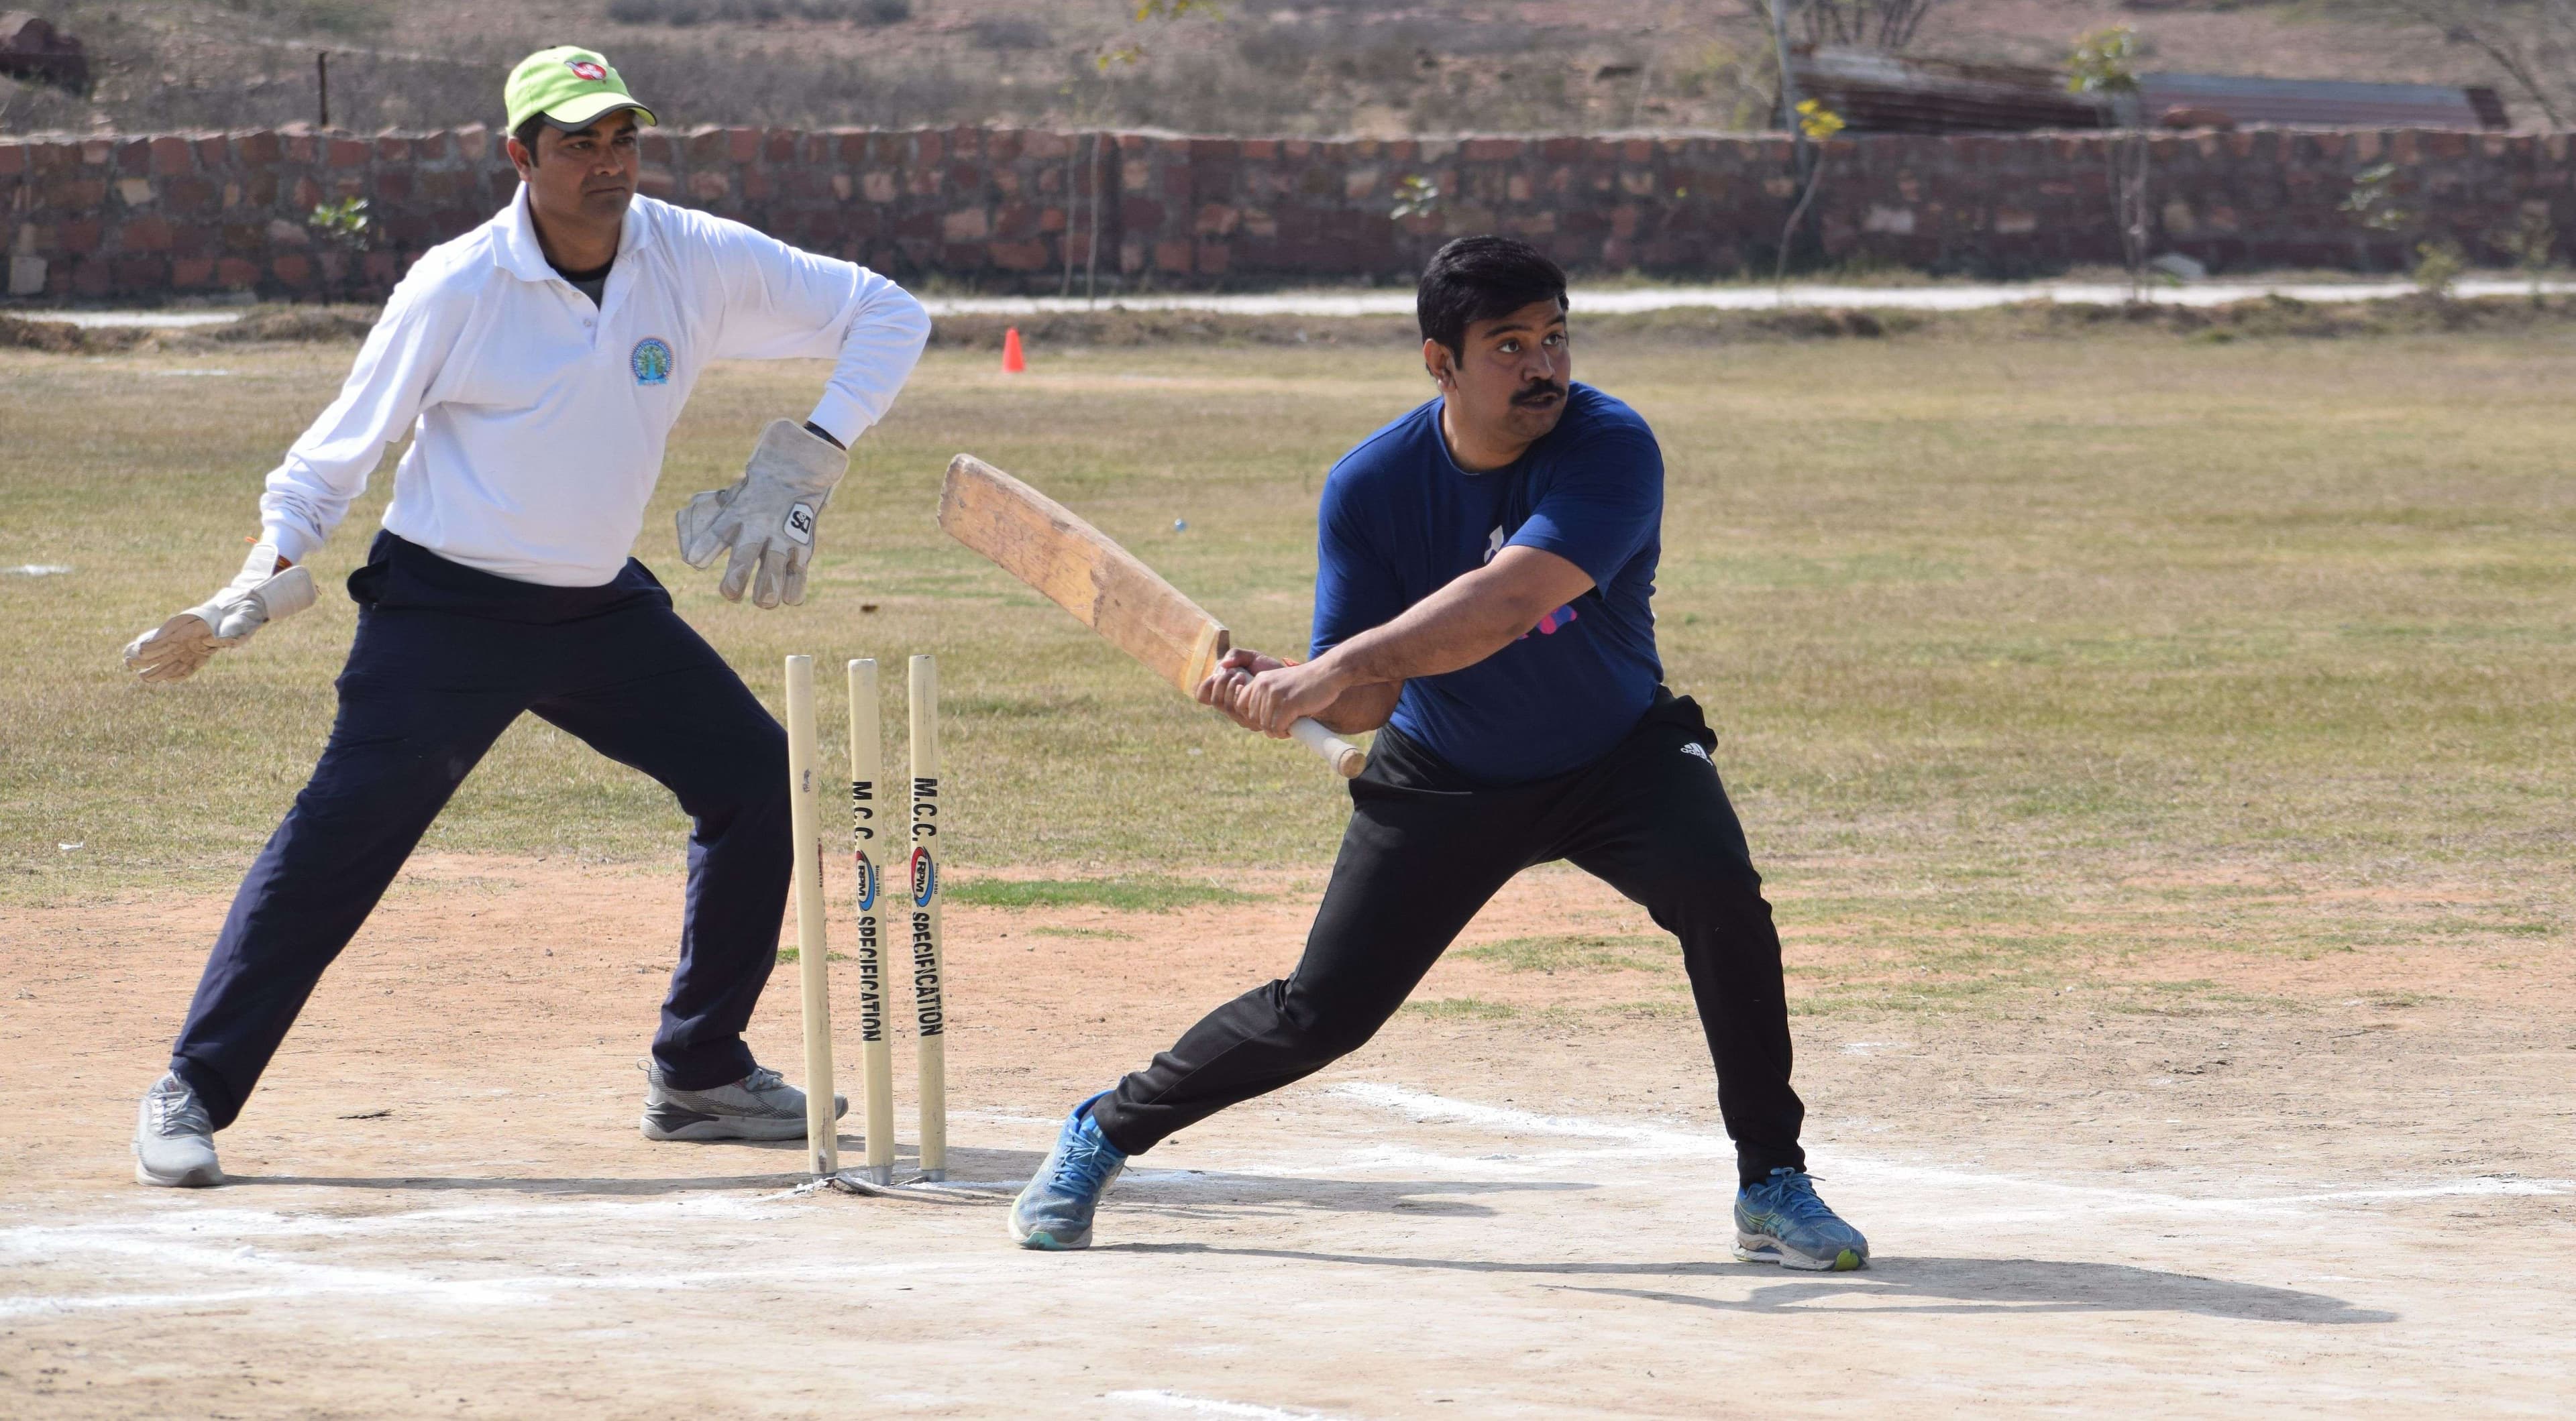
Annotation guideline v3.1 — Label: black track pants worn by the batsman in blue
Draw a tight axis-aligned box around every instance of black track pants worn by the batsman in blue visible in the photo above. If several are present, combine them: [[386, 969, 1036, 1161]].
[[1092, 695, 1806, 1182]]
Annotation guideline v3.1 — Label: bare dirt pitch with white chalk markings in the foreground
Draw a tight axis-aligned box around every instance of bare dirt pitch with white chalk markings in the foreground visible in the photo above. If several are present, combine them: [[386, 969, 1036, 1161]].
[[0, 857, 2576, 1418]]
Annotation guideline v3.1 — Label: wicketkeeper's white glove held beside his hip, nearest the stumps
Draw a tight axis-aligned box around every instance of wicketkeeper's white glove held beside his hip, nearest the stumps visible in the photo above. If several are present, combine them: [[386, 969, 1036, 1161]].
[[680, 420, 850, 608]]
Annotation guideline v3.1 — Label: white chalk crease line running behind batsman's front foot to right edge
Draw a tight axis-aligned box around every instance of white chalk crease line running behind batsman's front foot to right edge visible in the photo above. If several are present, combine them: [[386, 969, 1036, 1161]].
[[1327, 1081, 2576, 1215]]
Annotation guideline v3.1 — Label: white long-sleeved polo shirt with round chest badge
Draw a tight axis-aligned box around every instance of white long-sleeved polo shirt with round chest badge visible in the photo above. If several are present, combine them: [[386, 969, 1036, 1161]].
[[260, 185, 930, 587]]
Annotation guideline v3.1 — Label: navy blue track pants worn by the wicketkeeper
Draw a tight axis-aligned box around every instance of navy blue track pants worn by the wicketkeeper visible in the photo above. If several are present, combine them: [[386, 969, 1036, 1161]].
[[170, 533, 791, 1130]]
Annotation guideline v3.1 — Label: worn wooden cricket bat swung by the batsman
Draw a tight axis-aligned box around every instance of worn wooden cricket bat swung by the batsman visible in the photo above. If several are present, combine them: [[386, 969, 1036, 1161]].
[[941, 453, 1368, 780]]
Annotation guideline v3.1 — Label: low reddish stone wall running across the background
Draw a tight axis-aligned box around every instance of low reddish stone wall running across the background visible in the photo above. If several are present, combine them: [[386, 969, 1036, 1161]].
[[0, 126, 2576, 301]]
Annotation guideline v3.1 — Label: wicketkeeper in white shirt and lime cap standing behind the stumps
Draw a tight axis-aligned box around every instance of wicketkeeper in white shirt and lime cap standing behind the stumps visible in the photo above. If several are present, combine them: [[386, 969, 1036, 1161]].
[[126, 46, 930, 1184]]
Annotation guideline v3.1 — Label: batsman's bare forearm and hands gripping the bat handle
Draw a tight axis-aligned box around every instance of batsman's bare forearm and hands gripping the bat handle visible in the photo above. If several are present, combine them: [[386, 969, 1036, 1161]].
[[1200, 546, 1592, 736]]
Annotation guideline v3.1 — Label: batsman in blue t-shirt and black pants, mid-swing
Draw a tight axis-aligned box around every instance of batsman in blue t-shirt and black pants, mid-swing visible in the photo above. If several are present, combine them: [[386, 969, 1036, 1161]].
[[1010, 237, 1870, 1269]]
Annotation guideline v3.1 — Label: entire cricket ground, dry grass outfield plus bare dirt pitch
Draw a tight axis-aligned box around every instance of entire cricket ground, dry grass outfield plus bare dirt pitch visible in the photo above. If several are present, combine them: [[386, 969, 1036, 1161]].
[[0, 329, 2576, 1418]]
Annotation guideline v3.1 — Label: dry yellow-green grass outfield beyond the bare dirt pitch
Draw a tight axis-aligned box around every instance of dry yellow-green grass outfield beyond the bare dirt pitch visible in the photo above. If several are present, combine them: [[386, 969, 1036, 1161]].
[[0, 335, 2576, 1012]]
